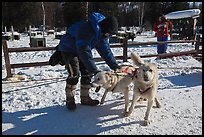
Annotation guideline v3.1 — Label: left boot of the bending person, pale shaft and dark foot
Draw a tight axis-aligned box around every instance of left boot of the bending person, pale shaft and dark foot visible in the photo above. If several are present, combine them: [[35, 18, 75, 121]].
[[65, 84, 76, 111]]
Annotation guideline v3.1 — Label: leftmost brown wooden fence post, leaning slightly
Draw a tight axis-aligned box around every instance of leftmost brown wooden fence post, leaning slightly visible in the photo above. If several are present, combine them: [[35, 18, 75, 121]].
[[2, 40, 12, 78]]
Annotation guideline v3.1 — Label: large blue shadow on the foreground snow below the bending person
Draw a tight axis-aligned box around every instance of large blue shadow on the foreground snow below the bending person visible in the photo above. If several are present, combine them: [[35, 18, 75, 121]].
[[2, 100, 142, 135]]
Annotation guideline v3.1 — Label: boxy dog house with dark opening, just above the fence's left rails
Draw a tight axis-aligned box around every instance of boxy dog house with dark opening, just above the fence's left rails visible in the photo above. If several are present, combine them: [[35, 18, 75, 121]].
[[30, 38, 46, 47]]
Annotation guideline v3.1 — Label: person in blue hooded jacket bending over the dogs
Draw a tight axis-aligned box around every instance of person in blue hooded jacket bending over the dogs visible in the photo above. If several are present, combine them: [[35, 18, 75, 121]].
[[49, 12, 120, 110]]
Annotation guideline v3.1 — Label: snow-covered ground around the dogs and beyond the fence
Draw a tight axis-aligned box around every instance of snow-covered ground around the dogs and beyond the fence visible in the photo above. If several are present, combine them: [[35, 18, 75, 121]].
[[2, 33, 202, 135]]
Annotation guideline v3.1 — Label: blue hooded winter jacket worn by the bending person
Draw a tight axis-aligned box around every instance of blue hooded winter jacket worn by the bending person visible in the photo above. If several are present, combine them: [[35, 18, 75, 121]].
[[58, 12, 118, 73]]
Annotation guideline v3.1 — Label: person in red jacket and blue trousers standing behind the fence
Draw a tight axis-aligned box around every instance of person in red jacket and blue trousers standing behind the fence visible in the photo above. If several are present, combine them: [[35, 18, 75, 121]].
[[153, 15, 172, 54]]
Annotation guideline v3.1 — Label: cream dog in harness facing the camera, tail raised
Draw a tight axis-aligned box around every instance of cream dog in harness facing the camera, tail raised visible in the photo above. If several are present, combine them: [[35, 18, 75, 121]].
[[124, 53, 161, 125]]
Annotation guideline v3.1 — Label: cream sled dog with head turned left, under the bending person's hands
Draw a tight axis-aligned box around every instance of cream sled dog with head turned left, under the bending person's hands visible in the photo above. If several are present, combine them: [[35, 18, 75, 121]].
[[92, 65, 135, 113]]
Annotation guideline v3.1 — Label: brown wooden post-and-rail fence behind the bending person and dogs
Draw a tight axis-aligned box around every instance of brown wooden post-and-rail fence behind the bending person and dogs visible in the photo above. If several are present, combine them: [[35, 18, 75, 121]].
[[2, 35, 202, 78]]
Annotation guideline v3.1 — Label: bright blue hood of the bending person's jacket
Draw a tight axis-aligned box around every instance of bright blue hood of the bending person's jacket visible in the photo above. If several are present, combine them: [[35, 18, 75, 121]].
[[88, 12, 106, 38]]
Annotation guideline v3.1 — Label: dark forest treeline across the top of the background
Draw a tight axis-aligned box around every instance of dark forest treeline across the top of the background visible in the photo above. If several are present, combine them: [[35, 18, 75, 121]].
[[2, 2, 202, 31]]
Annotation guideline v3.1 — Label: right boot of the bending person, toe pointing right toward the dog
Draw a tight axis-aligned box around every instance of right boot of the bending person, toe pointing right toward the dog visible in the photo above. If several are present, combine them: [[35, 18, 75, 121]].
[[80, 85, 99, 106]]
